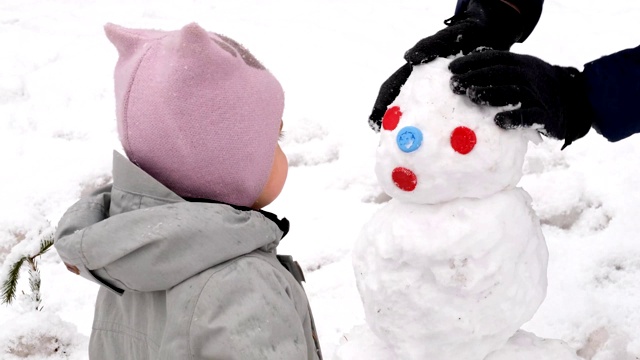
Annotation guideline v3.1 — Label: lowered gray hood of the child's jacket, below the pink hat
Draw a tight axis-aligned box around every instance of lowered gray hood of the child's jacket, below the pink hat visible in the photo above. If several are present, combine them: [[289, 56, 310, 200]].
[[55, 152, 288, 293]]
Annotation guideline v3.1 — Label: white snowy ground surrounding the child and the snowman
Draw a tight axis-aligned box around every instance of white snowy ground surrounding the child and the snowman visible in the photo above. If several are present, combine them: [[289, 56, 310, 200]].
[[0, 0, 640, 360]]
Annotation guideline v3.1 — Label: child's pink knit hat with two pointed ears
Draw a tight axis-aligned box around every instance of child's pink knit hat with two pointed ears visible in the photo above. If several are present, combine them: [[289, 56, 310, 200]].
[[105, 23, 284, 206]]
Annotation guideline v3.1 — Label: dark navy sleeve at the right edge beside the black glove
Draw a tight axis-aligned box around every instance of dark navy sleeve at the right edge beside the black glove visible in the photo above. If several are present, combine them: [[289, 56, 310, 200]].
[[584, 46, 640, 141]]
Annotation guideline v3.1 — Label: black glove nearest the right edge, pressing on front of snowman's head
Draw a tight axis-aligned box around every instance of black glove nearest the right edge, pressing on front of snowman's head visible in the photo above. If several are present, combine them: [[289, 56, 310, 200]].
[[449, 50, 593, 149]]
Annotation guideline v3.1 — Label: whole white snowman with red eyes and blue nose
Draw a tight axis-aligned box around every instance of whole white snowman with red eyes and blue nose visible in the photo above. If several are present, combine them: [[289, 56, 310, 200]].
[[352, 58, 548, 360]]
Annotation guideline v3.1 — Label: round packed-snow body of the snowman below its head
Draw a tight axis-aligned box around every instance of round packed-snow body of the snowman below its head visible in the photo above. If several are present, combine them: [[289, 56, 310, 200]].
[[352, 189, 548, 360]]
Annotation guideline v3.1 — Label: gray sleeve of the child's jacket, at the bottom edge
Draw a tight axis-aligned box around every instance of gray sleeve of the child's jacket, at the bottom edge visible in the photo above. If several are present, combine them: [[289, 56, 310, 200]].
[[189, 257, 317, 360]]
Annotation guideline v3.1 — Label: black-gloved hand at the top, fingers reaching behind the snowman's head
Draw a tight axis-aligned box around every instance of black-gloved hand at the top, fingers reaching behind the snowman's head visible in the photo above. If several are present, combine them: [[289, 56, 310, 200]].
[[369, 0, 523, 132]]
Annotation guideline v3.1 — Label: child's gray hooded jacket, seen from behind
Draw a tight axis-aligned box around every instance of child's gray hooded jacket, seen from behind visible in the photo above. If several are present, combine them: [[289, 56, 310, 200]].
[[55, 152, 318, 360]]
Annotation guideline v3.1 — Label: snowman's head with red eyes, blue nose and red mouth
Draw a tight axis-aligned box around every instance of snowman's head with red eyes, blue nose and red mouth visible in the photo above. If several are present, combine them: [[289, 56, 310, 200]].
[[376, 58, 541, 204]]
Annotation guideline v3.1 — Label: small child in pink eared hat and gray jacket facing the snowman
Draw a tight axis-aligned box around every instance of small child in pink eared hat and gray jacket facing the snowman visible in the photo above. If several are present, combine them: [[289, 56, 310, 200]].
[[55, 24, 321, 360]]
